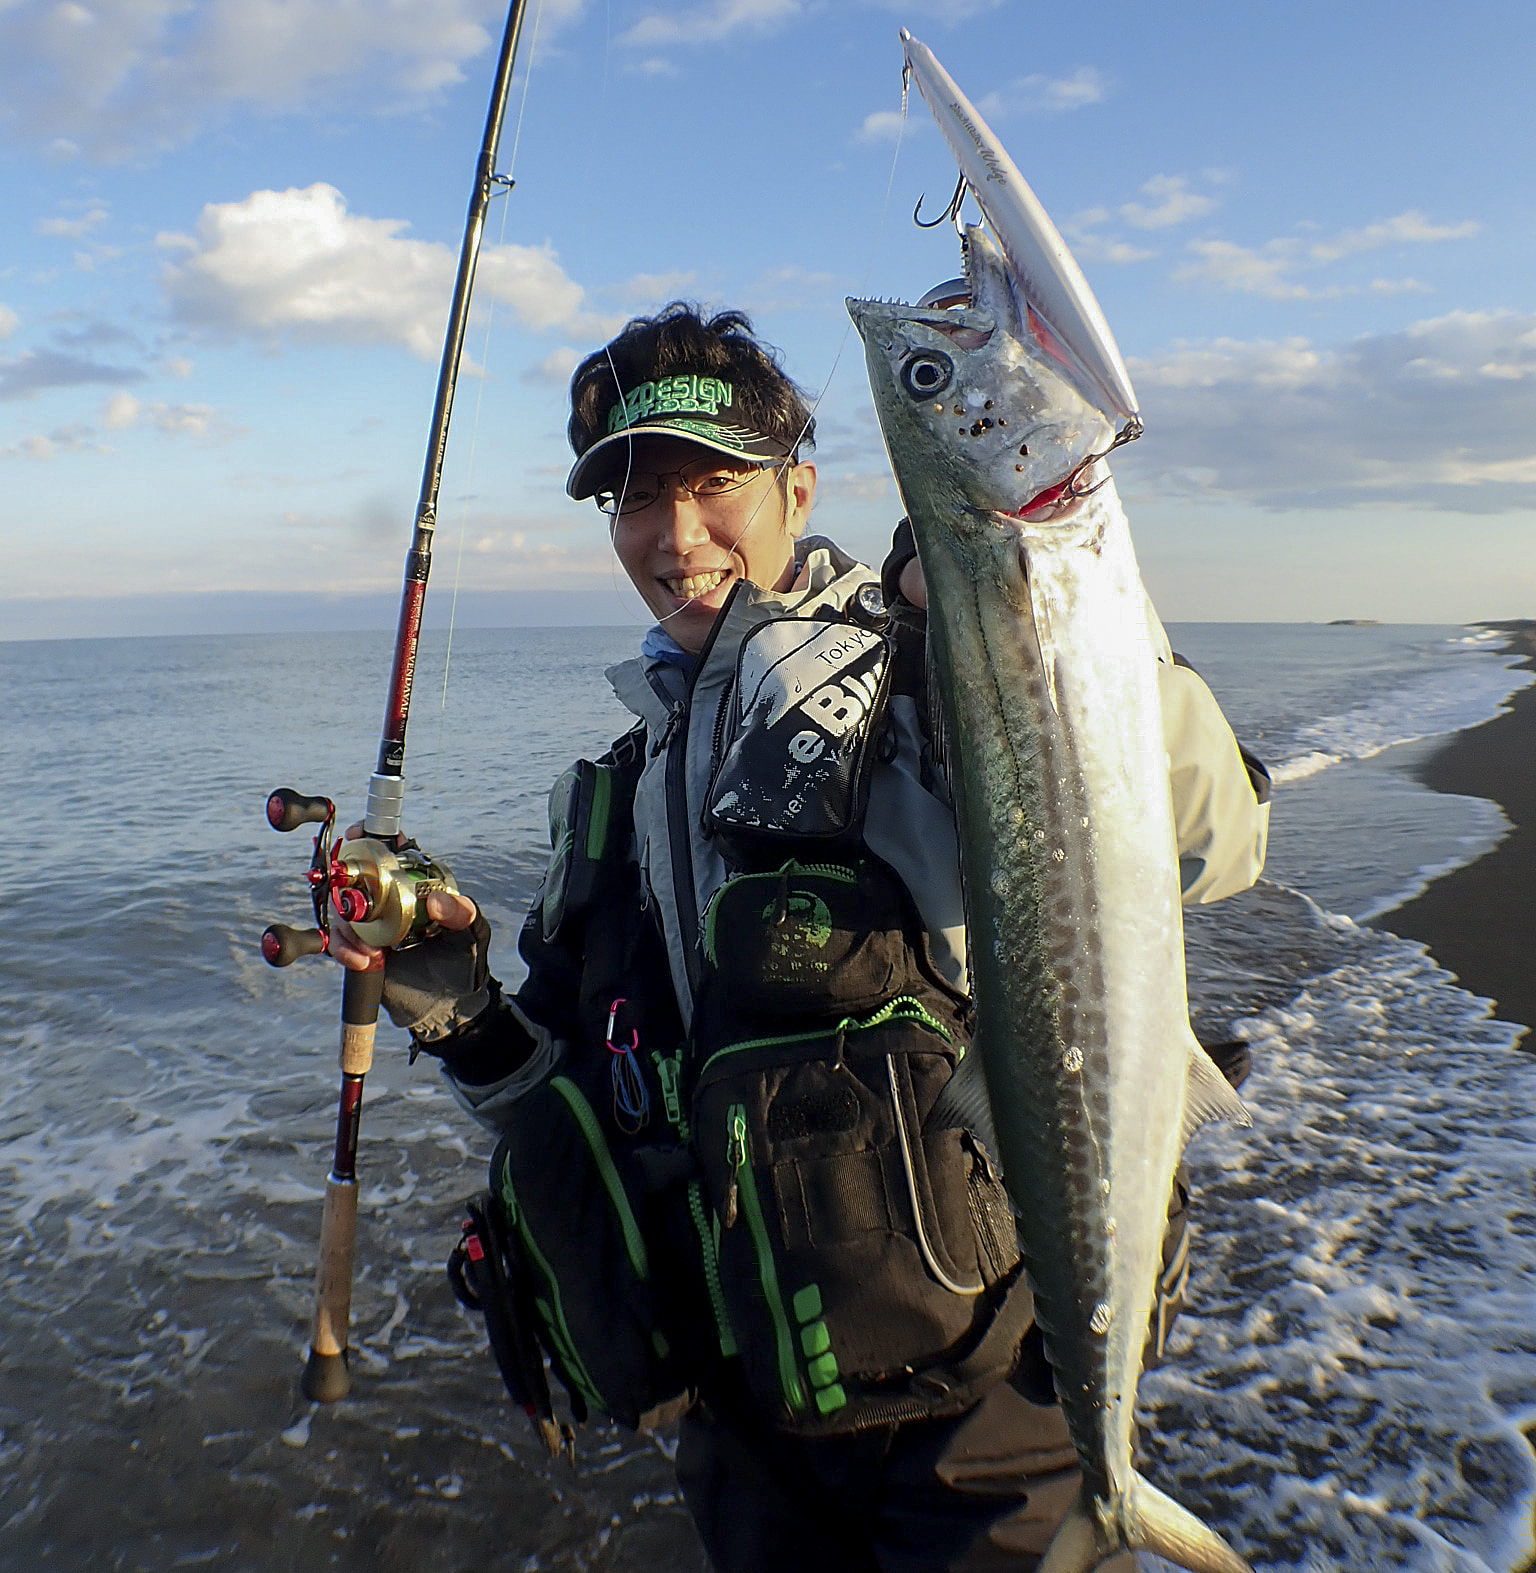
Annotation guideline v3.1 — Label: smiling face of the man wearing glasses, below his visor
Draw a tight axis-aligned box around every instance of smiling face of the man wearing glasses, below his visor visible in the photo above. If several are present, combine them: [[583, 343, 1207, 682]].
[[611, 437, 815, 654]]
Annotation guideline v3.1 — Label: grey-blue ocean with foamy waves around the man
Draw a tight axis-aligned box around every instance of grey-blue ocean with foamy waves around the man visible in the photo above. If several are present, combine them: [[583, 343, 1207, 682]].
[[0, 624, 1536, 1573]]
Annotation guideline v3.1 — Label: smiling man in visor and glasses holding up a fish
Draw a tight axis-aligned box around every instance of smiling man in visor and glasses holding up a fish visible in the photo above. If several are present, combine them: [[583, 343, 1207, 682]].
[[334, 302, 1267, 1573]]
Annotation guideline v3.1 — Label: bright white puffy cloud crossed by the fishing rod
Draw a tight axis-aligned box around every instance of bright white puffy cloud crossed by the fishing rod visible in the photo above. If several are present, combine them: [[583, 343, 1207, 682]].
[[161, 184, 607, 359]]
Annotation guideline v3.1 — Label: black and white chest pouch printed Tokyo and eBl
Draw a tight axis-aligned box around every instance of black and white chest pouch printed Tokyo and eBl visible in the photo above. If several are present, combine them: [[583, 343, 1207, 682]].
[[705, 618, 892, 845]]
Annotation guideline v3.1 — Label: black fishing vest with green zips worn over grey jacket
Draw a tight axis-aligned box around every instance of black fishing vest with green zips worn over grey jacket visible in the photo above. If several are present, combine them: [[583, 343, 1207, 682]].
[[472, 547, 1032, 1435]]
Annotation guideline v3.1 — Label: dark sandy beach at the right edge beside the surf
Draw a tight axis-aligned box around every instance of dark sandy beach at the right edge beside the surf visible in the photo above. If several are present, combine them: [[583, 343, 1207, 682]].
[[1371, 621, 1536, 1051]]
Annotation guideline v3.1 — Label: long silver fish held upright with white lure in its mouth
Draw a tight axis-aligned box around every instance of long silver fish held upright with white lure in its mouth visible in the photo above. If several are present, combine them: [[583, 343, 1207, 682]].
[[848, 35, 1251, 1573]]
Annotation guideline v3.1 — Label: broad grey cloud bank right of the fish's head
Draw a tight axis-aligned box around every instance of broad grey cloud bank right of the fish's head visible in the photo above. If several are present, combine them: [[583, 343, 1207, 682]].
[[1117, 311, 1536, 513]]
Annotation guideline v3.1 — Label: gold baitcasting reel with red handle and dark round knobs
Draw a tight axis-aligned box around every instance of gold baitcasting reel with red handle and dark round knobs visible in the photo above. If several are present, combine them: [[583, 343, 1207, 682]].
[[261, 787, 458, 967]]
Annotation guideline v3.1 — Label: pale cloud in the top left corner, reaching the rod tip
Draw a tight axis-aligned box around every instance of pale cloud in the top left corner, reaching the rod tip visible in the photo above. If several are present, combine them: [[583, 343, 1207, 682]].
[[0, 0, 581, 159]]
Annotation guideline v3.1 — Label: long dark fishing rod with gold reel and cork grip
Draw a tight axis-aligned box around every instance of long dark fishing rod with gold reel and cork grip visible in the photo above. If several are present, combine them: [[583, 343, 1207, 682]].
[[261, 0, 527, 1403]]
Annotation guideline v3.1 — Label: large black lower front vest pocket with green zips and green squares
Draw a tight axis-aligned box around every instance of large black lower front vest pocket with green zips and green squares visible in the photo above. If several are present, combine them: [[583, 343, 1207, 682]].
[[692, 997, 1017, 1431]]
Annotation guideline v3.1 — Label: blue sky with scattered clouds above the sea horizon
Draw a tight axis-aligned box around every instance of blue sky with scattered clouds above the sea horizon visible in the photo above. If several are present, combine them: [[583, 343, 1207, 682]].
[[0, 0, 1536, 639]]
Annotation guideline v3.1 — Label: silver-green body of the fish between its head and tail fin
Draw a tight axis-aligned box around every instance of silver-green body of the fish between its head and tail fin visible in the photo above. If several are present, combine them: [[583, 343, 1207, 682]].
[[914, 484, 1193, 1501]]
